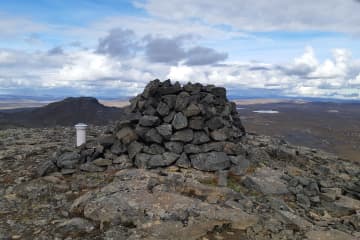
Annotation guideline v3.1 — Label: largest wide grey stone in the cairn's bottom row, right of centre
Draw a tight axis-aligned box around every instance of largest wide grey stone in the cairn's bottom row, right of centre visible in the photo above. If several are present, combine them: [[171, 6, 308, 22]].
[[190, 152, 231, 171]]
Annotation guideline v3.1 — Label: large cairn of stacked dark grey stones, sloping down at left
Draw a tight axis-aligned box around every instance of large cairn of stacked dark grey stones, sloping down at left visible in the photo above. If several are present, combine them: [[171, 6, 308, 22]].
[[42, 80, 249, 174]]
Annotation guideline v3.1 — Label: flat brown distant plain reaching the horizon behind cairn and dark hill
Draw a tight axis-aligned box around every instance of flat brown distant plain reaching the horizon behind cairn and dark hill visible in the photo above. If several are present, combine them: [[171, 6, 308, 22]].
[[0, 99, 360, 162]]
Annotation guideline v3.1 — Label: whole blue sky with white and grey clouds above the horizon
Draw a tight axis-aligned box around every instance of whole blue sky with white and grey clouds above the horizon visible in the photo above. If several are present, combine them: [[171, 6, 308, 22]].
[[0, 0, 360, 99]]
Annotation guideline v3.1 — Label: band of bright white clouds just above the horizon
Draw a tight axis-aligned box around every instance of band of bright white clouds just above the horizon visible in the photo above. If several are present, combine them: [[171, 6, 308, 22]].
[[0, 47, 360, 99]]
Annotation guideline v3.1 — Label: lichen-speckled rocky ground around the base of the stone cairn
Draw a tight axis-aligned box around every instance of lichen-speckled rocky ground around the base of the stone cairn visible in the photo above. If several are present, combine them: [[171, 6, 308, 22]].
[[0, 126, 360, 240]]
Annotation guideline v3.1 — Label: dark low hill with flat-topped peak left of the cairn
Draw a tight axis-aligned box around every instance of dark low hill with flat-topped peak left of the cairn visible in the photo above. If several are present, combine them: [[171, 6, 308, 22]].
[[0, 97, 125, 128]]
